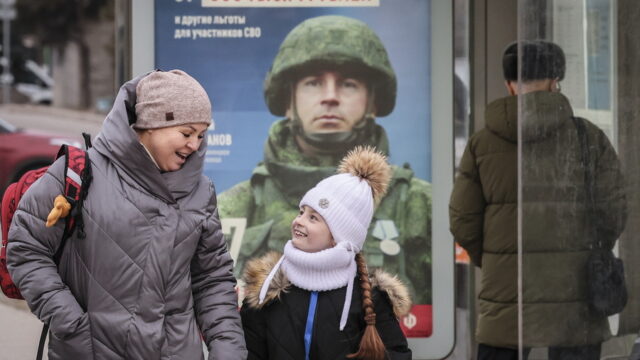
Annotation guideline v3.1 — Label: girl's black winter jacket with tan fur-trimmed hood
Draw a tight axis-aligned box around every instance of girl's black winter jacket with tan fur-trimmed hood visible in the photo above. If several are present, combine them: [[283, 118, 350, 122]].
[[241, 252, 411, 360]]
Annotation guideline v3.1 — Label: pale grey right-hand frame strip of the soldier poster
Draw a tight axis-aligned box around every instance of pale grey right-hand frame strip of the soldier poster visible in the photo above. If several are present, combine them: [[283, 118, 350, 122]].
[[418, 0, 456, 360]]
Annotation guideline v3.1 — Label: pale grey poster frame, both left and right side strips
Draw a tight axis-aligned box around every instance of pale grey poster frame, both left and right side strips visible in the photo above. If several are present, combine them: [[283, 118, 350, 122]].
[[129, 0, 455, 360]]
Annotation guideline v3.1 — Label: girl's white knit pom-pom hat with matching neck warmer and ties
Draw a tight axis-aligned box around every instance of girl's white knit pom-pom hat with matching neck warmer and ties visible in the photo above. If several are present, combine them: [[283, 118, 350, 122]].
[[259, 147, 391, 330]]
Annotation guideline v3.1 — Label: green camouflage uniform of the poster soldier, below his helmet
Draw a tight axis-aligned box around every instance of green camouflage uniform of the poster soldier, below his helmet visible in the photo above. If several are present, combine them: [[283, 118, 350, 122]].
[[218, 119, 432, 304]]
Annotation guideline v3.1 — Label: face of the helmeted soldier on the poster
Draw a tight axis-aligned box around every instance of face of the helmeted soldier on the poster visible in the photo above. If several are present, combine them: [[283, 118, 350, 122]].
[[287, 71, 368, 134]]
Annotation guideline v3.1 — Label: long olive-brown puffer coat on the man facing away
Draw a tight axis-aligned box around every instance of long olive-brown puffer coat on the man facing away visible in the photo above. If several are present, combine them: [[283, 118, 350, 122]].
[[450, 92, 626, 348]]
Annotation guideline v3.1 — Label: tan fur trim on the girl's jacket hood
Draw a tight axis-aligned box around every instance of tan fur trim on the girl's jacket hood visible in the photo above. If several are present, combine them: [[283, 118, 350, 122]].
[[242, 251, 412, 317]]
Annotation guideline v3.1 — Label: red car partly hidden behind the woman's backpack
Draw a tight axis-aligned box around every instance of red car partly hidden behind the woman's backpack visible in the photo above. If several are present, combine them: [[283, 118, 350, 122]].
[[0, 119, 82, 198]]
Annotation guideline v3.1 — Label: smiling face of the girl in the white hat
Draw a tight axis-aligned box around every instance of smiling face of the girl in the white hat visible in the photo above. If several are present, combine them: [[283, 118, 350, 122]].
[[291, 205, 336, 252]]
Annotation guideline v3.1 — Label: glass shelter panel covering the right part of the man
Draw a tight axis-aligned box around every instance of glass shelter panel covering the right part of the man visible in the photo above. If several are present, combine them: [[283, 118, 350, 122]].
[[516, 0, 640, 359]]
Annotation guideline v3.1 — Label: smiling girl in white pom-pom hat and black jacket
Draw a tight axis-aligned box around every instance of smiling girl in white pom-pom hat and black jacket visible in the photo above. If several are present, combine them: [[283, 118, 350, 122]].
[[241, 147, 411, 360]]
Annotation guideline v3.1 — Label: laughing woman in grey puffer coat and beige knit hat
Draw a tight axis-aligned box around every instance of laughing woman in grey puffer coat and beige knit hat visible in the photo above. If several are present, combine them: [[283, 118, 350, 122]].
[[7, 70, 246, 360]]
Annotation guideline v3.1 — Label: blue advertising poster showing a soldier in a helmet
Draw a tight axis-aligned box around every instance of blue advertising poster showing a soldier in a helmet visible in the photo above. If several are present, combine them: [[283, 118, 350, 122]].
[[154, 0, 433, 338]]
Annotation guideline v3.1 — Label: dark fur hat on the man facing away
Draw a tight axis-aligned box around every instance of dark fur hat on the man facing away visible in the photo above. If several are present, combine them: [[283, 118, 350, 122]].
[[502, 40, 566, 81]]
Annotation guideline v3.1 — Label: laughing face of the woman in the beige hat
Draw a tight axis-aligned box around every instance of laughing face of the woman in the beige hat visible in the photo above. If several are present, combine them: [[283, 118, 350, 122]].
[[138, 123, 208, 171]]
